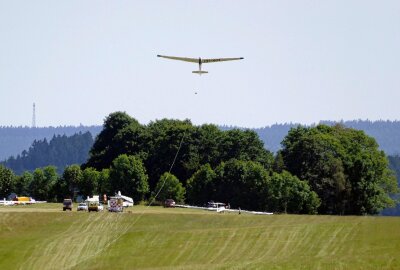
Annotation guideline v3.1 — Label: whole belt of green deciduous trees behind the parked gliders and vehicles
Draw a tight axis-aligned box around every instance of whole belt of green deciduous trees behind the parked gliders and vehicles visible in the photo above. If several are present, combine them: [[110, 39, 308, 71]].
[[0, 112, 398, 214]]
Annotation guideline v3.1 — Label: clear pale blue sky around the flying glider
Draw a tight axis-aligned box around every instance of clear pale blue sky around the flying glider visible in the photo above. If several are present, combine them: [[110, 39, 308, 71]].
[[0, 0, 400, 128]]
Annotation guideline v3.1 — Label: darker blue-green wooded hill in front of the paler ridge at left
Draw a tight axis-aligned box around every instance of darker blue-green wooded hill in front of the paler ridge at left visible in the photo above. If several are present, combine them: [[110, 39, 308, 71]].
[[0, 131, 93, 174]]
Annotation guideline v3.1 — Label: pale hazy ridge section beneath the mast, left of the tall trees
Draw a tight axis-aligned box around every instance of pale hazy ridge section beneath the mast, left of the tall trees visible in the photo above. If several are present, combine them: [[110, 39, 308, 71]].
[[0, 126, 103, 161]]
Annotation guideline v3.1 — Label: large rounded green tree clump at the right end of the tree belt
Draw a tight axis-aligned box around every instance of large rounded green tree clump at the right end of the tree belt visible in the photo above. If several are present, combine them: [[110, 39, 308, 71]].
[[282, 125, 397, 214]]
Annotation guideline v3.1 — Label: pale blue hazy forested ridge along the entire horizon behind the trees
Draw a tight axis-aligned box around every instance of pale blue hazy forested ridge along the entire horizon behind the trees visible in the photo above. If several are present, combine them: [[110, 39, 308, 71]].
[[0, 120, 400, 160]]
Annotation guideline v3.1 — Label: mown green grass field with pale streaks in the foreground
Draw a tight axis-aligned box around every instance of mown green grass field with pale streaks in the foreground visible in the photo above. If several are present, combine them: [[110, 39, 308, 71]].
[[0, 204, 400, 269]]
